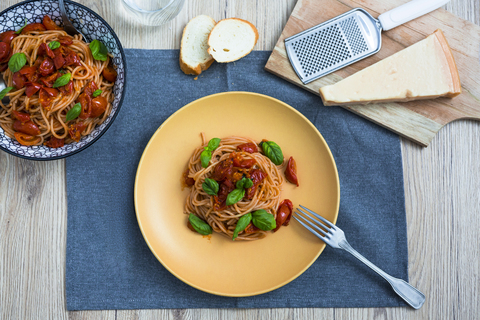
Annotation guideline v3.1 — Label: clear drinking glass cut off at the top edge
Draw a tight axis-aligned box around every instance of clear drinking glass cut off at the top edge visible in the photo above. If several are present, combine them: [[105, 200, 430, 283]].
[[121, 0, 185, 26]]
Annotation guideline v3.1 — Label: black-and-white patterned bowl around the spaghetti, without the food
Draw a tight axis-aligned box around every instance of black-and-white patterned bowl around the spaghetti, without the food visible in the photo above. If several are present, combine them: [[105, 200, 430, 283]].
[[0, 0, 126, 160]]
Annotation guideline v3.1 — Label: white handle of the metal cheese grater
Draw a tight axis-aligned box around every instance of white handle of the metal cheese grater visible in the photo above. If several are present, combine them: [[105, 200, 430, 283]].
[[378, 0, 450, 31]]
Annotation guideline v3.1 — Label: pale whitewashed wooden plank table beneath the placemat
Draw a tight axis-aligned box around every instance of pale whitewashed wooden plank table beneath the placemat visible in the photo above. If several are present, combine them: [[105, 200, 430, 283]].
[[0, 0, 480, 320]]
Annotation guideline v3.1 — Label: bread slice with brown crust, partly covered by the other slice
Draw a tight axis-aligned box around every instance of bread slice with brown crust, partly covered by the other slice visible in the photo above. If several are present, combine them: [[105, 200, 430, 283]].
[[180, 15, 215, 75]]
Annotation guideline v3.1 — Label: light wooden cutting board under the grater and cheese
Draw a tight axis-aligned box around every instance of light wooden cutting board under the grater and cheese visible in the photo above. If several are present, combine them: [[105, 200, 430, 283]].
[[265, 0, 480, 147]]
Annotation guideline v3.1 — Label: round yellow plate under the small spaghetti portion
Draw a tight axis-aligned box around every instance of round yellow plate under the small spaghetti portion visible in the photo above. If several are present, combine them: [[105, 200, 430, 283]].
[[135, 92, 340, 297]]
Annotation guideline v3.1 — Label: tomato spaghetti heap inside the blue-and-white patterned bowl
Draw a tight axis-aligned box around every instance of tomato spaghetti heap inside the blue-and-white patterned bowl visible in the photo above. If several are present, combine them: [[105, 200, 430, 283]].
[[0, 17, 116, 147]]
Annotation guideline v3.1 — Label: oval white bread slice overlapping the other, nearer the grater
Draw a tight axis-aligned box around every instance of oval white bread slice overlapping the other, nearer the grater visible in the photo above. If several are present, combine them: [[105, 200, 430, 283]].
[[208, 18, 258, 62]]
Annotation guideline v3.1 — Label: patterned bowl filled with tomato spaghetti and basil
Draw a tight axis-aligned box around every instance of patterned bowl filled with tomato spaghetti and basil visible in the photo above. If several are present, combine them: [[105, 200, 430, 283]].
[[0, 0, 126, 160]]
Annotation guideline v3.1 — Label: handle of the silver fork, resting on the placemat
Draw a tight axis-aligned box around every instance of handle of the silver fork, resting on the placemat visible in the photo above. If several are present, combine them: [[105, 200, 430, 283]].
[[339, 240, 425, 309]]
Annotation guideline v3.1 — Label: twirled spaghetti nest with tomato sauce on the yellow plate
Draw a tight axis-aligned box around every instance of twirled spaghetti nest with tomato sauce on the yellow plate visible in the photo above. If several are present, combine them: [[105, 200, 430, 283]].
[[184, 134, 285, 240]]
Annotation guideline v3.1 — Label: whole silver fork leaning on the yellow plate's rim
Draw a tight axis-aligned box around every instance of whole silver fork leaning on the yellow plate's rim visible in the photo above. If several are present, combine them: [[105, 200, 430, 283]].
[[293, 206, 425, 309]]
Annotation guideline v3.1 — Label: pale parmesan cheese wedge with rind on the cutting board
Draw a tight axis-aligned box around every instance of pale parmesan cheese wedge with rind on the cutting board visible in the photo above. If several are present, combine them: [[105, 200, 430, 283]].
[[320, 29, 461, 106]]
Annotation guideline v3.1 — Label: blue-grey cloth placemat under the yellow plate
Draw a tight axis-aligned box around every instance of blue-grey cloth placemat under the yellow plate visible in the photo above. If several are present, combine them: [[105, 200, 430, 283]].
[[66, 49, 408, 310]]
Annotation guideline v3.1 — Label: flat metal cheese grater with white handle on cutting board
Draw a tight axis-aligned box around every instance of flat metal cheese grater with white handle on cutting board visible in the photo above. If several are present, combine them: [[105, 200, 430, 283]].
[[285, 0, 449, 84]]
